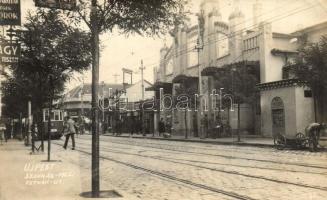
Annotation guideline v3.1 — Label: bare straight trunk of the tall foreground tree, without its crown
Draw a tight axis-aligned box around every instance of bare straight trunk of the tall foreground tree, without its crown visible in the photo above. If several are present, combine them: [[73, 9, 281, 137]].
[[90, 0, 100, 197]]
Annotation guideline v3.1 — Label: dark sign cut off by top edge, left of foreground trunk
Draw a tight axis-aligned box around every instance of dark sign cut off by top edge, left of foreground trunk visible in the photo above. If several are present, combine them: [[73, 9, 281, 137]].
[[35, 0, 76, 10]]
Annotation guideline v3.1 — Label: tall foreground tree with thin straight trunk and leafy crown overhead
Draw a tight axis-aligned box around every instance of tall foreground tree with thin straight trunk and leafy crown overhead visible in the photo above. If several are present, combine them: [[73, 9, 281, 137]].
[[71, 0, 187, 197]]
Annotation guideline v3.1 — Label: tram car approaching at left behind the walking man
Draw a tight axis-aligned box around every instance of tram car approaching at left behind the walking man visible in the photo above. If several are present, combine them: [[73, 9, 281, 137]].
[[37, 108, 64, 140]]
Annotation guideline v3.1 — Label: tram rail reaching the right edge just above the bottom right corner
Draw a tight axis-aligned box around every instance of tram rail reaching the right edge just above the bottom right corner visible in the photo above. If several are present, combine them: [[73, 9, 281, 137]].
[[53, 140, 327, 191]]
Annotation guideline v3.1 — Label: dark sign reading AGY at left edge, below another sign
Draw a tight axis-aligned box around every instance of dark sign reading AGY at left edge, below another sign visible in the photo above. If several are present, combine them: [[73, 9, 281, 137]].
[[0, 41, 20, 64]]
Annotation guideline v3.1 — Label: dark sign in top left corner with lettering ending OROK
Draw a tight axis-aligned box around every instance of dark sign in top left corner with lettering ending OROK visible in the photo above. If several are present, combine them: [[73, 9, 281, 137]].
[[0, 0, 21, 26]]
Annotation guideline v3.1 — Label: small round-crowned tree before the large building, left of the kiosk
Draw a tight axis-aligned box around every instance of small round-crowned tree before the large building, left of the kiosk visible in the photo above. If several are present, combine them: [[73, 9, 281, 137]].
[[214, 61, 259, 141]]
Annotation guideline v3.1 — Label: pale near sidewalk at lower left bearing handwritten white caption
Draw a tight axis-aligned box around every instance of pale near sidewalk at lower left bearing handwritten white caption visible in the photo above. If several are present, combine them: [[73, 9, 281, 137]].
[[0, 140, 136, 200]]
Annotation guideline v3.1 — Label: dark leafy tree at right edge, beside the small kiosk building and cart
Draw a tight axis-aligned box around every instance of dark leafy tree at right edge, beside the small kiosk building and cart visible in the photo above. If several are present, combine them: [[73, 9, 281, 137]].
[[295, 35, 327, 121]]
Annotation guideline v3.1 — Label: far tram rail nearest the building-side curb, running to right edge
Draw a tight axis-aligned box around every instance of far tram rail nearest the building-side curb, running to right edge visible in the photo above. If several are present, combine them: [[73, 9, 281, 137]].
[[77, 139, 327, 169]]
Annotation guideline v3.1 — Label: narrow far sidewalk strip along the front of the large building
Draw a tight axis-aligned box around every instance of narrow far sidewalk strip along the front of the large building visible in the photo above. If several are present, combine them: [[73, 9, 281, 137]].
[[104, 133, 274, 147]]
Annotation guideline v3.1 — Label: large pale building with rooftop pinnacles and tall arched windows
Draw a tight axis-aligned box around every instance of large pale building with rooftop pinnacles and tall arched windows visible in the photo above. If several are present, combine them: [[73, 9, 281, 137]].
[[154, 0, 260, 136]]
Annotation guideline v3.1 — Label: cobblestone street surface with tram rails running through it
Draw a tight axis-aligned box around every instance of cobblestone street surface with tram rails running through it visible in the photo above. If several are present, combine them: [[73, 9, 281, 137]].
[[54, 135, 327, 200]]
